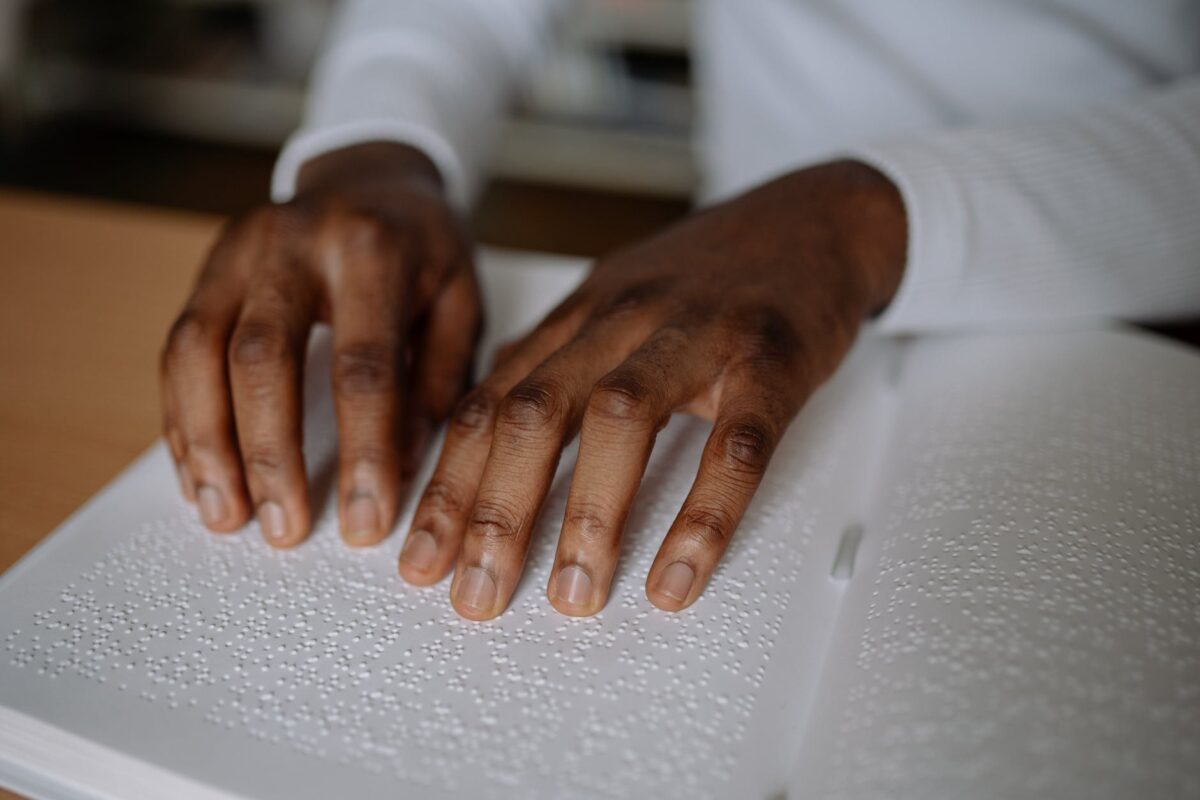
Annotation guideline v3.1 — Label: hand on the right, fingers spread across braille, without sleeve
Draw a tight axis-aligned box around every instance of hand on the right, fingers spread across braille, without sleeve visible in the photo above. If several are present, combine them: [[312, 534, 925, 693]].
[[400, 162, 907, 619]]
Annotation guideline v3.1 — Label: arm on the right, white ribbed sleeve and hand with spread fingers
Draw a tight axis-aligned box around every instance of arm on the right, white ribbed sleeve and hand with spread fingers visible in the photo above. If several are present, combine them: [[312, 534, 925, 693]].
[[401, 77, 1200, 619]]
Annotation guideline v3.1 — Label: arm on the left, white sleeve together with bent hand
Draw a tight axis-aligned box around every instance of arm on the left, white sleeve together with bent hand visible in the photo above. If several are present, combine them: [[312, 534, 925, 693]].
[[161, 0, 566, 547]]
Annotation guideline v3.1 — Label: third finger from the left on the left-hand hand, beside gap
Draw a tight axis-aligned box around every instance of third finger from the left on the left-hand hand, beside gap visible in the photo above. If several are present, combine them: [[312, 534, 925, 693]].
[[332, 222, 413, 546]]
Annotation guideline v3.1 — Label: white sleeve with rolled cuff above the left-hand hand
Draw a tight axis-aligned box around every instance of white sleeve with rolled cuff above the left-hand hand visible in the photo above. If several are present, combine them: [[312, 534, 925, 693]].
[[271, 0, 566, 206]]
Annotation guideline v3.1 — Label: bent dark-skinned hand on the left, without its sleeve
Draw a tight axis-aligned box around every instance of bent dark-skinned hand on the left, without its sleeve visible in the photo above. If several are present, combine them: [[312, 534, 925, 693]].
[[161, 143, 480, 547]]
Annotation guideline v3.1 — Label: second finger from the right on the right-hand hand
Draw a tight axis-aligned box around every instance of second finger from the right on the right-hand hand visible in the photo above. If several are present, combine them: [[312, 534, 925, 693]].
[[546, 326, 722, 616]]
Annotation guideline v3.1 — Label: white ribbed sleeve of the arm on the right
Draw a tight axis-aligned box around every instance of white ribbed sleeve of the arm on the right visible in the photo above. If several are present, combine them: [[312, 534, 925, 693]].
[[848, 78, 1200, 332]]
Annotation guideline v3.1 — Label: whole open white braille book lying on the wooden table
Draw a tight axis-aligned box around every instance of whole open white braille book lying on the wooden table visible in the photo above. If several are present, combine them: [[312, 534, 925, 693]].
[[0, 254, 1200, 799]]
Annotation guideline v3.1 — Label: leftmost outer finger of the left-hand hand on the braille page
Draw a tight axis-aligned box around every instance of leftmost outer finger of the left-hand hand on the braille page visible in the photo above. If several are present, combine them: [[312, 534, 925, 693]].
[[161, 287, 250, 533]]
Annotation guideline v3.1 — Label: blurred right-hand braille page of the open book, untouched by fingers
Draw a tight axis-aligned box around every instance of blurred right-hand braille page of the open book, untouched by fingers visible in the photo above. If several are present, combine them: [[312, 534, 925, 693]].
[[788, 331, 1200, 800]]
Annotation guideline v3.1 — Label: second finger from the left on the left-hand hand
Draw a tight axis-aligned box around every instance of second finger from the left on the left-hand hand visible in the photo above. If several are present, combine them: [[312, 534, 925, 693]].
[[229, 260, 317, 547]]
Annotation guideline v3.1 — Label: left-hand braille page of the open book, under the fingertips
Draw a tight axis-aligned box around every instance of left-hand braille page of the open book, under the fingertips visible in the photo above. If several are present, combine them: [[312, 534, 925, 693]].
[[0, 251, 887, 799]]
